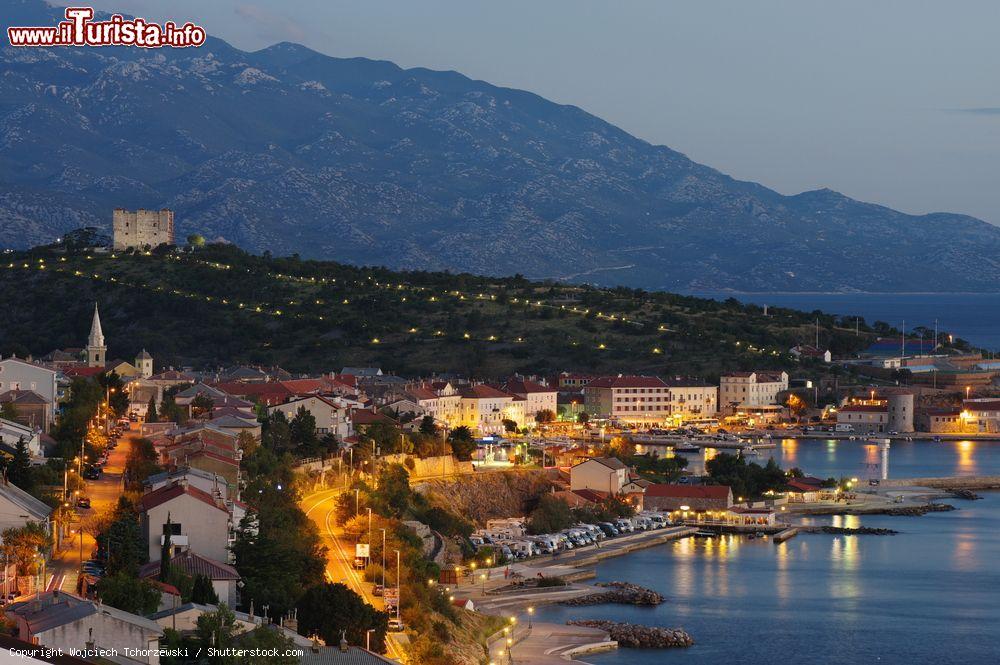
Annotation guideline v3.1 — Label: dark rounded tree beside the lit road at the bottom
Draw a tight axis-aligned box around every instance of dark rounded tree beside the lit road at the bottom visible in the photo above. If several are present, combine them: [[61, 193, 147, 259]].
[[296, 584, 389, 652]]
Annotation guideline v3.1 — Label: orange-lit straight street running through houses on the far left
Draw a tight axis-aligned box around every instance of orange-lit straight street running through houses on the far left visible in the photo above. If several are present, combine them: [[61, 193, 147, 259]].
[[46, 423, 139, 593]]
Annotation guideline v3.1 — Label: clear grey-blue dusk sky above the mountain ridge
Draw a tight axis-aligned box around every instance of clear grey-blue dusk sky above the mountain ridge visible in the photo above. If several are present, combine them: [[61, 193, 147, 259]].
[[82, 0, 1000, 224]]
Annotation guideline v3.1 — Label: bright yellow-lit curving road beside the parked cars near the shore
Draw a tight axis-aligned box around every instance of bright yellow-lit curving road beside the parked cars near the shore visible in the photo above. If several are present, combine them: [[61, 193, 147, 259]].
[[301, 489, 406, 662]]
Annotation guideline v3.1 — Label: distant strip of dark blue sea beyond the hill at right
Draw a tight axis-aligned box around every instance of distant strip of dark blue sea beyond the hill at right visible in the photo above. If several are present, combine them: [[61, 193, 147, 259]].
[[692, 293, 1000, 351]]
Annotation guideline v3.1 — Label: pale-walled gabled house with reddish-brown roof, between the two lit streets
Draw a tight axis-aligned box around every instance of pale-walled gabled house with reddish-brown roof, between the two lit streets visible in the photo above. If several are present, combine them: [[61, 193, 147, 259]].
[[139, 479, 233, 561]]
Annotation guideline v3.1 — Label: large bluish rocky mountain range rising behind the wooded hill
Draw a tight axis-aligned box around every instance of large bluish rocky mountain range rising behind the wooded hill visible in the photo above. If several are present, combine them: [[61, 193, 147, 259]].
[[0, 0, 1000, 291]]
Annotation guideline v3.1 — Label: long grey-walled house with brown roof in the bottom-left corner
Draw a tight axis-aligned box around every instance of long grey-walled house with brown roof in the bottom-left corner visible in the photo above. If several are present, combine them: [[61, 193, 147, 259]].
[[4, 591, 163, 665]]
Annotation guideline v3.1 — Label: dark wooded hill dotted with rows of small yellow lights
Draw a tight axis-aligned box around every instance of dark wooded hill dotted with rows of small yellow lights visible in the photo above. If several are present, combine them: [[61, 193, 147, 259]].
[[0, 240, 888, 378]]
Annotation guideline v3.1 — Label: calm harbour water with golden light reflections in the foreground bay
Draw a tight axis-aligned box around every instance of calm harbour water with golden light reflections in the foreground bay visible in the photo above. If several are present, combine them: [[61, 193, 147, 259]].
[[538, 441, 1000, 665]]
